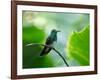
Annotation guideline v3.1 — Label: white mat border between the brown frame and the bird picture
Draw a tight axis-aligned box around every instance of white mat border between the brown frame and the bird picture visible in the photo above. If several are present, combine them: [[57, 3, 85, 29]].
[[17, 5, 94, 75]]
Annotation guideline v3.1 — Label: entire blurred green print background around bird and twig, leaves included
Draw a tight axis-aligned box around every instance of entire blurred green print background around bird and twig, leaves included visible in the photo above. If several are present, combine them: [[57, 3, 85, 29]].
[[22, 11, 90, 68]]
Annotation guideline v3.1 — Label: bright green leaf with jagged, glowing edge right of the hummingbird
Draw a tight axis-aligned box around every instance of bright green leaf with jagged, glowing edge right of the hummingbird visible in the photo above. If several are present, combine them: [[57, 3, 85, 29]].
[[67, 26, 90, 66]]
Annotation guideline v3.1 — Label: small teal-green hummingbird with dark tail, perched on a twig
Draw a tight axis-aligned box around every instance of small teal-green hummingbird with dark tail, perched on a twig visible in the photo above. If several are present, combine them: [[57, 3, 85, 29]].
[[40, 29, 60, 56]]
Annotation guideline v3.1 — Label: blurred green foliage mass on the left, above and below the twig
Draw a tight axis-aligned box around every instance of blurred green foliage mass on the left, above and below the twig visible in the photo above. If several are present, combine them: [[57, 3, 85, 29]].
[[23, 26, 53, 68]]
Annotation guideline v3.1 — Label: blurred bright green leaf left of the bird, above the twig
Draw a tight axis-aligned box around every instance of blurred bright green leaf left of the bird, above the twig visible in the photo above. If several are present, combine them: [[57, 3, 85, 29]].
[[23, 26, 45, 43]]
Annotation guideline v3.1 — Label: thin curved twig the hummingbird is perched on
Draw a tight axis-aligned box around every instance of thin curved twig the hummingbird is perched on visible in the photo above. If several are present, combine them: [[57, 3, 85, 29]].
[[26, 43, 69, 67]]
